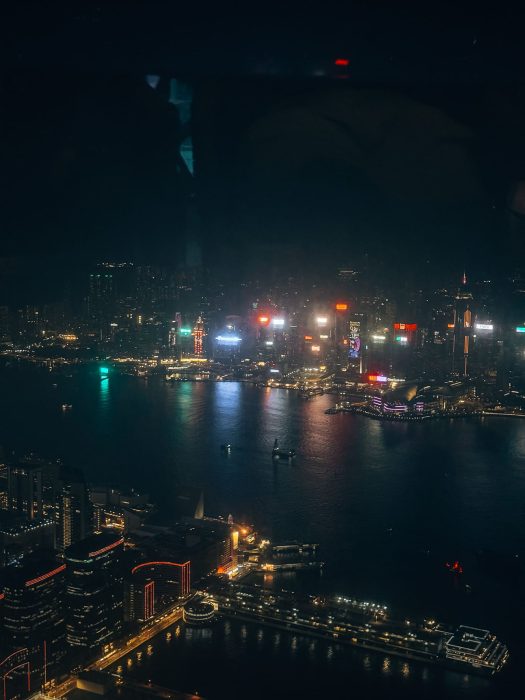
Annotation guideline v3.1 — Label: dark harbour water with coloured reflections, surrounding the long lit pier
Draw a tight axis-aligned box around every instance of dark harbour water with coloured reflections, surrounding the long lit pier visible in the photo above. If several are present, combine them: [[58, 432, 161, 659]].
[[0, 367, 525, 698]]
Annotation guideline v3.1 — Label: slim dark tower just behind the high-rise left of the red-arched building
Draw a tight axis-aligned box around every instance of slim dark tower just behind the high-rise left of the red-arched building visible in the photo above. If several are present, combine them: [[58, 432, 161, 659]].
[[57, 469, 93, 551]]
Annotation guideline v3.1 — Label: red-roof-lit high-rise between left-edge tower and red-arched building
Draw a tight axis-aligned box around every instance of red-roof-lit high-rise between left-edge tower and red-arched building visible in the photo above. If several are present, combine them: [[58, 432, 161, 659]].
[[65, 531, 124, 651]]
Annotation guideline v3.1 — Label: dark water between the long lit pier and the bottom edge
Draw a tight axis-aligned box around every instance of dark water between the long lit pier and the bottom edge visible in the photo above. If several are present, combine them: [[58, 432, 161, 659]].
[[114, 619, 498, 700]]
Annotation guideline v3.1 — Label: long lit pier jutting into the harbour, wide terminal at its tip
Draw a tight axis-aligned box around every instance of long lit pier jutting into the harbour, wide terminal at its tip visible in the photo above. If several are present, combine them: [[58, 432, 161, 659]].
[[201, 581, 509, 675]]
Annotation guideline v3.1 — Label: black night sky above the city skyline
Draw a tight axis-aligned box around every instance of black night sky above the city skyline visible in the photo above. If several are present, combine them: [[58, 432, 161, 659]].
[[0, 3, 525, 296]]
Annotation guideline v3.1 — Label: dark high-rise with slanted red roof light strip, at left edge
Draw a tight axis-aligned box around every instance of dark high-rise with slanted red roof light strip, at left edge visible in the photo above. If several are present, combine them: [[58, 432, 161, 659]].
[[2, 559, 67, 689]]
